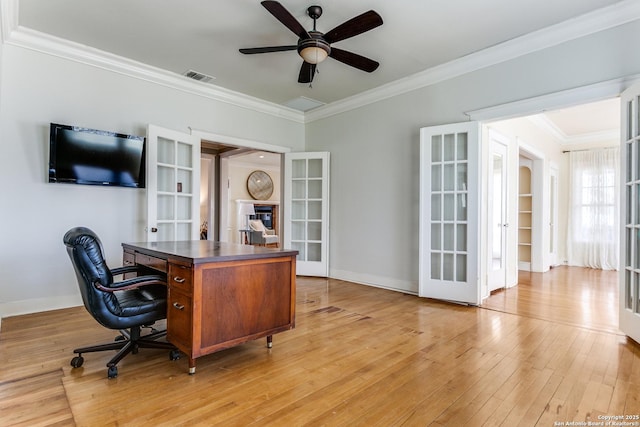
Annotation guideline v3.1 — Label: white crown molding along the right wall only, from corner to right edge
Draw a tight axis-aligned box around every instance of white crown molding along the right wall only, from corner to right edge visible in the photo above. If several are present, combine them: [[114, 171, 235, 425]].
[[305, 0, 640, 123]]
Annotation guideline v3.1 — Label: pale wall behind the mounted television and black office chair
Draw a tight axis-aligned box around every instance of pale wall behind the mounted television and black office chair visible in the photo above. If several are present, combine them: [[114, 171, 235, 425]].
[[0, 45, 304, 317]]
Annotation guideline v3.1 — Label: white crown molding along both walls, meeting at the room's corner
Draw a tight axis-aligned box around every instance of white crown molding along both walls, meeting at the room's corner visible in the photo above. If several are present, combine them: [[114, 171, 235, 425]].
[[0, 0, 640, 123]]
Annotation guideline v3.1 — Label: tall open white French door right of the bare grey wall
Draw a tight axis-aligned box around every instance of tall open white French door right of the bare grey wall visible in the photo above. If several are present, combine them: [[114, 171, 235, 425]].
[[418, 122, 481, 305]]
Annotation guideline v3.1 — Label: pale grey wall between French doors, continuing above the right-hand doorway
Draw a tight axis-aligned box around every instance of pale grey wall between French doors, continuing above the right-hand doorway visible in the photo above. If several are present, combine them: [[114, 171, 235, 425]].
[[306, 21, 640, 292]]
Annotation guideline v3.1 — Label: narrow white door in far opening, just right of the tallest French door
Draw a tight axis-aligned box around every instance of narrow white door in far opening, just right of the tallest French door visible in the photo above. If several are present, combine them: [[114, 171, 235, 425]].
[[487, 131, 509, 292]]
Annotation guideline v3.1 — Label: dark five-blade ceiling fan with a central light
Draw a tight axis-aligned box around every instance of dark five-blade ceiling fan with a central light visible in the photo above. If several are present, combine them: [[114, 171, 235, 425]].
[[240, 1, 382, 83]]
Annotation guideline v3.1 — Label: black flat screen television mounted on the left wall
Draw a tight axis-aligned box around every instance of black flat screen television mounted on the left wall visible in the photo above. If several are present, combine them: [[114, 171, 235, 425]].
[[49, 123, 145, 188]]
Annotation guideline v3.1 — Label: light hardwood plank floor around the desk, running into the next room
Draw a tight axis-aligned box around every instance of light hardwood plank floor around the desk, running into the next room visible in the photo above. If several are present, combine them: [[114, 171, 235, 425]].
[[0, 267, 640, 426]]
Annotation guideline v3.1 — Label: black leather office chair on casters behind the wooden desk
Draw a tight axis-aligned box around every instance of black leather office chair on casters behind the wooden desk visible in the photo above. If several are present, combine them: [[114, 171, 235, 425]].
[[64, 227, 180, 378]]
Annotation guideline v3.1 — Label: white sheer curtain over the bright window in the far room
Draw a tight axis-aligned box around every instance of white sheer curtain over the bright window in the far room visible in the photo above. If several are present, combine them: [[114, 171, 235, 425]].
[[567, 148, 620, 270]]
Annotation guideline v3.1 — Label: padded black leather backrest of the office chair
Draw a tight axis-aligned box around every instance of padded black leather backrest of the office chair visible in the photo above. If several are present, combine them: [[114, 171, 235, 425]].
[[63, 227, 120, 328]]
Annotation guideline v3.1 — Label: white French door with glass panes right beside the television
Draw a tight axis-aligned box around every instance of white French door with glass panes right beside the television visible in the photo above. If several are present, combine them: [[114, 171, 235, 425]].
[[147, 125, 200, 242]]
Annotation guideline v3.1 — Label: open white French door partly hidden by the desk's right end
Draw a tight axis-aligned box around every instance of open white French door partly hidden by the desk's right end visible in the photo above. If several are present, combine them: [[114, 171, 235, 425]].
[[284, 152, 329, 277]]
